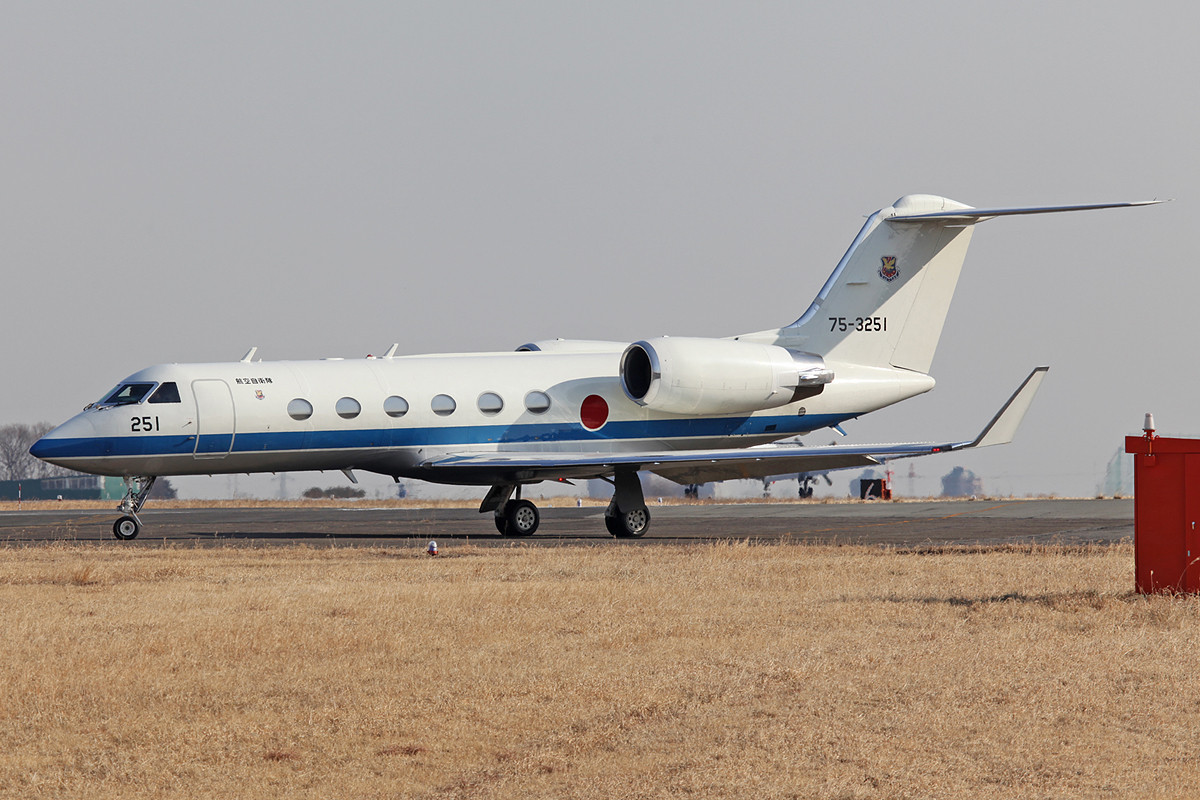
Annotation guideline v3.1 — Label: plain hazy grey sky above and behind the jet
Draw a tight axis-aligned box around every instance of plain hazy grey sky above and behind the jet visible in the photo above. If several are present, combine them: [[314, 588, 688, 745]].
[[0, 2, 1200, 494]]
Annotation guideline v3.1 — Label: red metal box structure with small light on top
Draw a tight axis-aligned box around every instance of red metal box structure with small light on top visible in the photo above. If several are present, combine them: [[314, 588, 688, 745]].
[[1126, 414, 1200, 594]]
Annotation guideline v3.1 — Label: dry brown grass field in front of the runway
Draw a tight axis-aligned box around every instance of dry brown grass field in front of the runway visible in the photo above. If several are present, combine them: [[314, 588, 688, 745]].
[[0, 545, 1200, 799]]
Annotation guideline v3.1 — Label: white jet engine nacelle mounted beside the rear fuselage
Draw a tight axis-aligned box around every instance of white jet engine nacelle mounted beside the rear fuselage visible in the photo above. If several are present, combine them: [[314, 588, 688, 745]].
[[620, 337, 833, 414]]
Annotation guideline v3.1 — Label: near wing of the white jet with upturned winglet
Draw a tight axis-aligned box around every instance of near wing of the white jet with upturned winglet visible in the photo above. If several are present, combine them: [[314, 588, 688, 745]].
[[422, 367, 1049, 485]]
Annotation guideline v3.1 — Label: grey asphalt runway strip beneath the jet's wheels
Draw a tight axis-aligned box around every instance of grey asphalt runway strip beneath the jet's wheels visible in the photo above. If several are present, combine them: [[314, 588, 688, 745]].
[[0, 500, 1133, 547]]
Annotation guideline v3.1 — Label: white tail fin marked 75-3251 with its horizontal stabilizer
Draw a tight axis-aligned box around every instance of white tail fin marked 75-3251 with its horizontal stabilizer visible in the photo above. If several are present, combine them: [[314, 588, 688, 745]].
[[778, 194, 1154, 373]]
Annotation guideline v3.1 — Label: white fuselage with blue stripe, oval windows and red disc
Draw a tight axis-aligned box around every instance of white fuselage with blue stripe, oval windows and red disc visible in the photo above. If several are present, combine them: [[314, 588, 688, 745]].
[[25, 344, 934, 483]]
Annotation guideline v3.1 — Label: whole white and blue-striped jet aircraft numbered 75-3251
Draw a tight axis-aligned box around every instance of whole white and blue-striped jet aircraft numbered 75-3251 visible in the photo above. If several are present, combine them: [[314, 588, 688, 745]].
[[31, 194, 1153, 540]]
